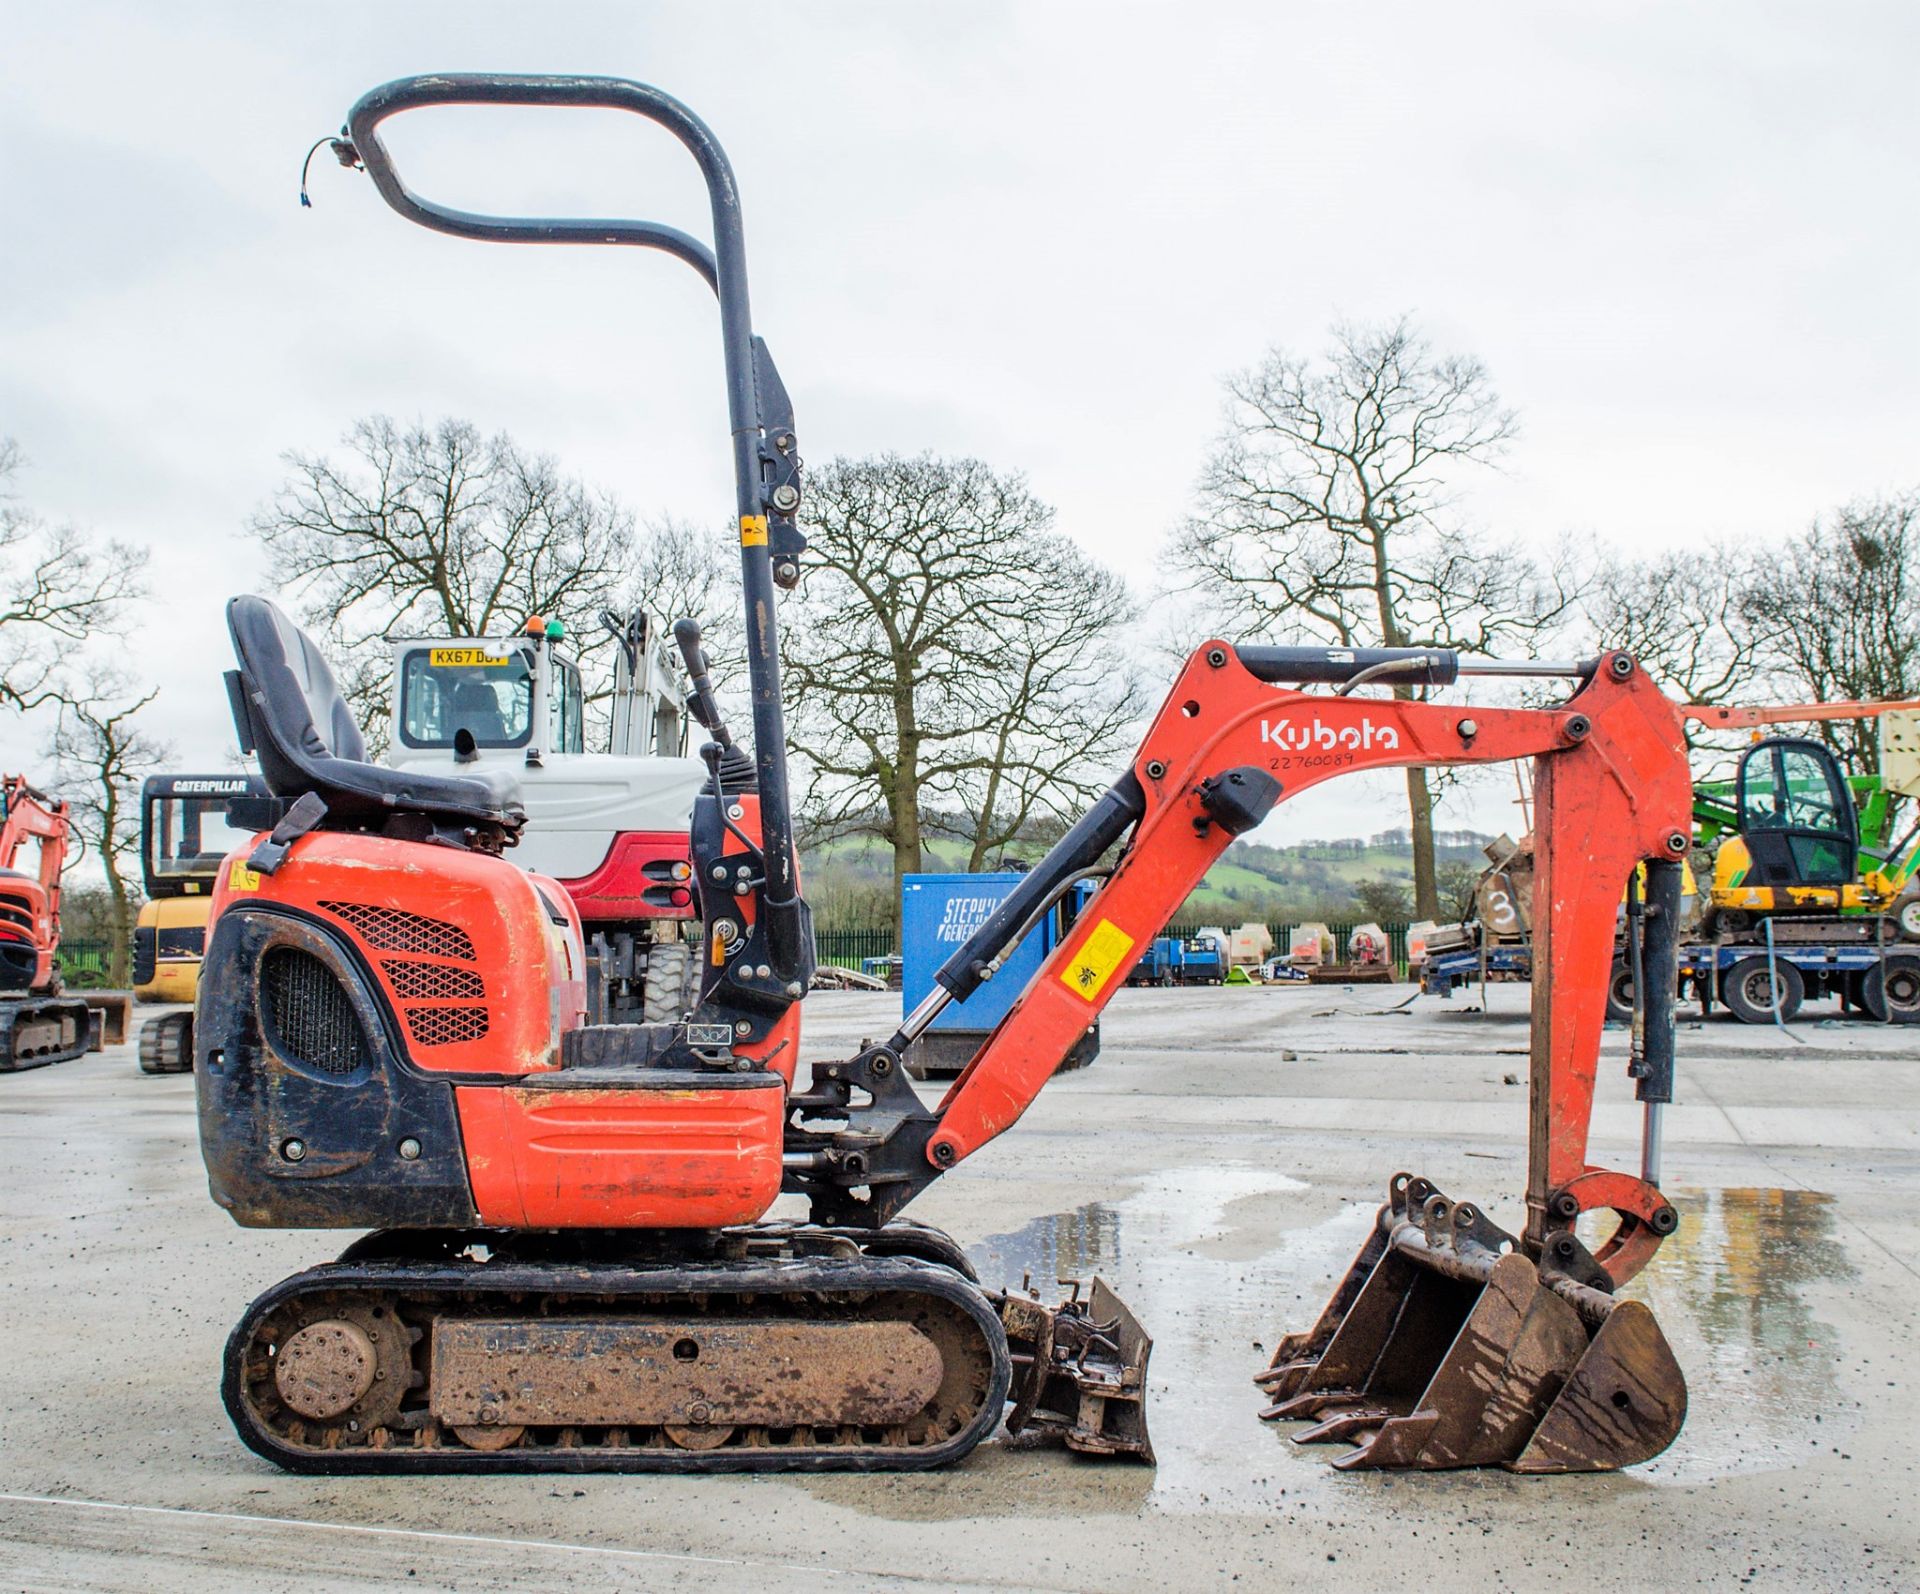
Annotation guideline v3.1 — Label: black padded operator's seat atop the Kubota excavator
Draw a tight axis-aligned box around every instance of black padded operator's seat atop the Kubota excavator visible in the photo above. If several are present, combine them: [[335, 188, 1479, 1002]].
[[227, 595, 526, 833]]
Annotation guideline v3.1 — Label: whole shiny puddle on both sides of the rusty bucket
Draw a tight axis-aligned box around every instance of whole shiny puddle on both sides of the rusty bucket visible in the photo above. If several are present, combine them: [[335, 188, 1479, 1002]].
[[808, 1166, 1859, 1519]]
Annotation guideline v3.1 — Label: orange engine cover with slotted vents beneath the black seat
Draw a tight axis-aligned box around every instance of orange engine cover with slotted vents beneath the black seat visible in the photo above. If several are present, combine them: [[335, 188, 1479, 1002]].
[[209, 830, 586, 1077]]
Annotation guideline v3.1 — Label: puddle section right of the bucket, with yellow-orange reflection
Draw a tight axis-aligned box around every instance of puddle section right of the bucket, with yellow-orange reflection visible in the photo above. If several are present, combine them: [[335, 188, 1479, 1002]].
[[1628, 1189, 1859, 1483]]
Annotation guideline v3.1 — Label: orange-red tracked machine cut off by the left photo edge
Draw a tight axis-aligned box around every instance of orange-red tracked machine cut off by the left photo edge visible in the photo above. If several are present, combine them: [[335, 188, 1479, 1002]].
[[0, 774, 92, 1070]]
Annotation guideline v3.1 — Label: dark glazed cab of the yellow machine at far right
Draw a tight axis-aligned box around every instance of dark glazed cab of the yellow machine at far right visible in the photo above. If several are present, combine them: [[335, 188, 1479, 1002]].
[[1734, 736, 1860, 887]]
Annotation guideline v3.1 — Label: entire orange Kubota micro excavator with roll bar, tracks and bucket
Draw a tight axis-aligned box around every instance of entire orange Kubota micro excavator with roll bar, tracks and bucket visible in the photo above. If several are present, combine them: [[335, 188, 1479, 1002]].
[[196, 75, 1690, 1473]]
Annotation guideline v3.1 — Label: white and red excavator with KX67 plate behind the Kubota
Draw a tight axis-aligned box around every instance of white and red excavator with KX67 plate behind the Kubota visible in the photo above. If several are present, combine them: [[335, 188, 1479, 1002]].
[[386, 611, 707, 1024]]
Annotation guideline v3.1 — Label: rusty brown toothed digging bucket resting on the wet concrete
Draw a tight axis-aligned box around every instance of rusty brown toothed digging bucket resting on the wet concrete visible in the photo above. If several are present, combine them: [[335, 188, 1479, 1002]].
[[1256, 1173, 1686, 1473]]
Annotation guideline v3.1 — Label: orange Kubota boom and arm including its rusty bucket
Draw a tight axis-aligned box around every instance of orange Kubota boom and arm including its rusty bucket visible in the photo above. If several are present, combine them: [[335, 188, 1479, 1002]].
[[787, 641, 1692, 1471]]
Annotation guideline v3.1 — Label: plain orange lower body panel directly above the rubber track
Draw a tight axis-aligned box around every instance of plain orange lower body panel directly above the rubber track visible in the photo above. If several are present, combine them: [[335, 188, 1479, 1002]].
[[455, 1074, 787, 1229]]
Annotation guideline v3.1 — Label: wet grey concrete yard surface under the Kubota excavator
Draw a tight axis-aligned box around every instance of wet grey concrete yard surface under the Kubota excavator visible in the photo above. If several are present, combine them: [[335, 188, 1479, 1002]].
[[0, 985, 1920, 1594]]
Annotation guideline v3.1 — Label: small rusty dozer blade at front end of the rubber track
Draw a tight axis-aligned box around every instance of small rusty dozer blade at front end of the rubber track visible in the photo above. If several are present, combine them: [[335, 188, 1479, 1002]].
[[998, 1277, 1154, 1465]]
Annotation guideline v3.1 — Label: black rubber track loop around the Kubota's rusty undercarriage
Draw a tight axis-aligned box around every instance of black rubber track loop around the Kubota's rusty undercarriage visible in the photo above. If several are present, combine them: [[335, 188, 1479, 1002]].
[[221, 1256, 1012, 1475]]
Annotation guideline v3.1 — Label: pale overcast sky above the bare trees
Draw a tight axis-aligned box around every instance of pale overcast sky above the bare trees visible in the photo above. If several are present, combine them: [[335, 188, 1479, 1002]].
[[0, 0, 1920, 860]]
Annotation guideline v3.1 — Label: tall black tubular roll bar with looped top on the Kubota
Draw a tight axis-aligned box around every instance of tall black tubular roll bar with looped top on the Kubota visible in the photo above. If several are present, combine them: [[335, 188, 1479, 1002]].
[[334, 73, 812, 979]]
